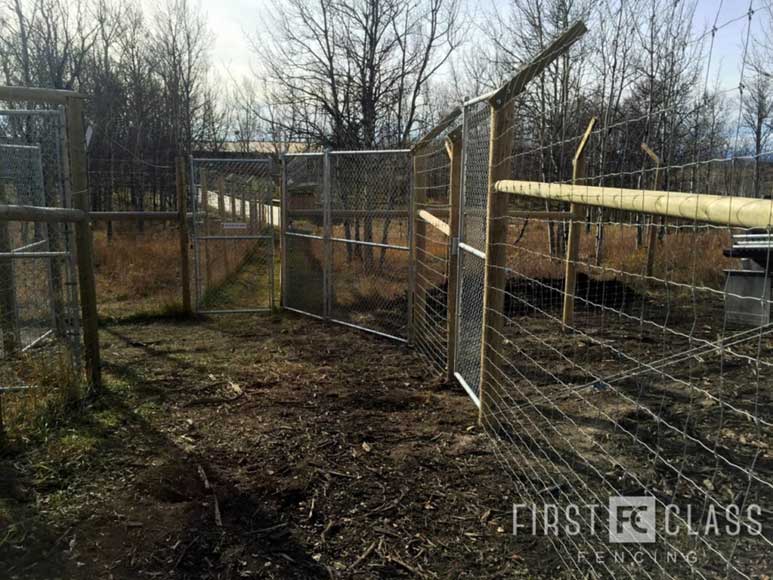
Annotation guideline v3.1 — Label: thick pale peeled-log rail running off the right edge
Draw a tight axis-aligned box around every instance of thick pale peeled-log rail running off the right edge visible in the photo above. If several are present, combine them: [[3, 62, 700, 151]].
[[495, 179, 773, 228]]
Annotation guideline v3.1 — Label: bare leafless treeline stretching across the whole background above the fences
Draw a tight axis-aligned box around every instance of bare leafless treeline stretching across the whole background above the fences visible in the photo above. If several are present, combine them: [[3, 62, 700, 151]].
[[0, 0, 773, 213]]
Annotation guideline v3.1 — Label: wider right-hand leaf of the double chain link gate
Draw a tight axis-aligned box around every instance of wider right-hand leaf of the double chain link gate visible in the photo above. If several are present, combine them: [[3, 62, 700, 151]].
[[329, 151, 410, 339]]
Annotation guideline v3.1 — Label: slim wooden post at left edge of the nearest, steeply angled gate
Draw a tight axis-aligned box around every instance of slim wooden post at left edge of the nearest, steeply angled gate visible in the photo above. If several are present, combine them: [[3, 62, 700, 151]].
[[446, 127, 463, 383]]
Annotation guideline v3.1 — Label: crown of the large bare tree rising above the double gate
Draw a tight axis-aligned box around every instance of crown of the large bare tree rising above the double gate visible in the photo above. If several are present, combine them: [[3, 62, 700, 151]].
[[254, 0, 459, 148]]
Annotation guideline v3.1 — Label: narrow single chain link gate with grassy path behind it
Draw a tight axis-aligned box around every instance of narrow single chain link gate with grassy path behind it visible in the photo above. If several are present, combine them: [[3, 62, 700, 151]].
[[191, 158, 277, 314]]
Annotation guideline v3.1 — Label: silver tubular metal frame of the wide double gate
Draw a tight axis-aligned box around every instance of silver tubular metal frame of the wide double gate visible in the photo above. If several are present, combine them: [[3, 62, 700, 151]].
[[281, 149, 414, 343]]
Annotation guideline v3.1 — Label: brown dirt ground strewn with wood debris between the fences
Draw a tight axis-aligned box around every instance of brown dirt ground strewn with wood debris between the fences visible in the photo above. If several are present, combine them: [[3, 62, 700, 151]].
[[0, 315, 557, 580]]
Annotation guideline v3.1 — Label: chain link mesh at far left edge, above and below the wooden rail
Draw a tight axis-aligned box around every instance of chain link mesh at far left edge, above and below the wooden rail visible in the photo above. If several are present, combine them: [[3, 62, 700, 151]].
[[0, 108, 82, 435]]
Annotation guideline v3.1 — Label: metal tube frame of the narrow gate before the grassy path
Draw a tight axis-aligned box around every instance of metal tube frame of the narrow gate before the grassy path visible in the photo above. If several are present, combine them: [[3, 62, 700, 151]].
[[190, 156, 276, 314]]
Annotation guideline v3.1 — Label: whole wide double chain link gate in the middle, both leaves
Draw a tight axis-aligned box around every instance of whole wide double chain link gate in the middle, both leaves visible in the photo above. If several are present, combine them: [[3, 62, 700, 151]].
[[282, 150, 412, 342]]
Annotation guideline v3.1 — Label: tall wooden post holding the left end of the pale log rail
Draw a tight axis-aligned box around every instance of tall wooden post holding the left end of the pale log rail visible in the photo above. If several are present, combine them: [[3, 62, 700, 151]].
[[479, 97, 514, 425]]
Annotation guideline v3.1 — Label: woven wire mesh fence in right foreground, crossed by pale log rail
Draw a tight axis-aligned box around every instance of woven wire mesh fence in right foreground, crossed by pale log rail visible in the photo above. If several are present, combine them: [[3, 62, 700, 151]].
[[468, 6, 773, 578]]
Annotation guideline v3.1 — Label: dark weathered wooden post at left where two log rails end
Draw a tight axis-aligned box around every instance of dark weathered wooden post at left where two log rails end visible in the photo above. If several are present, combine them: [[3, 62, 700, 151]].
[[66, 98, 102, 390]]
